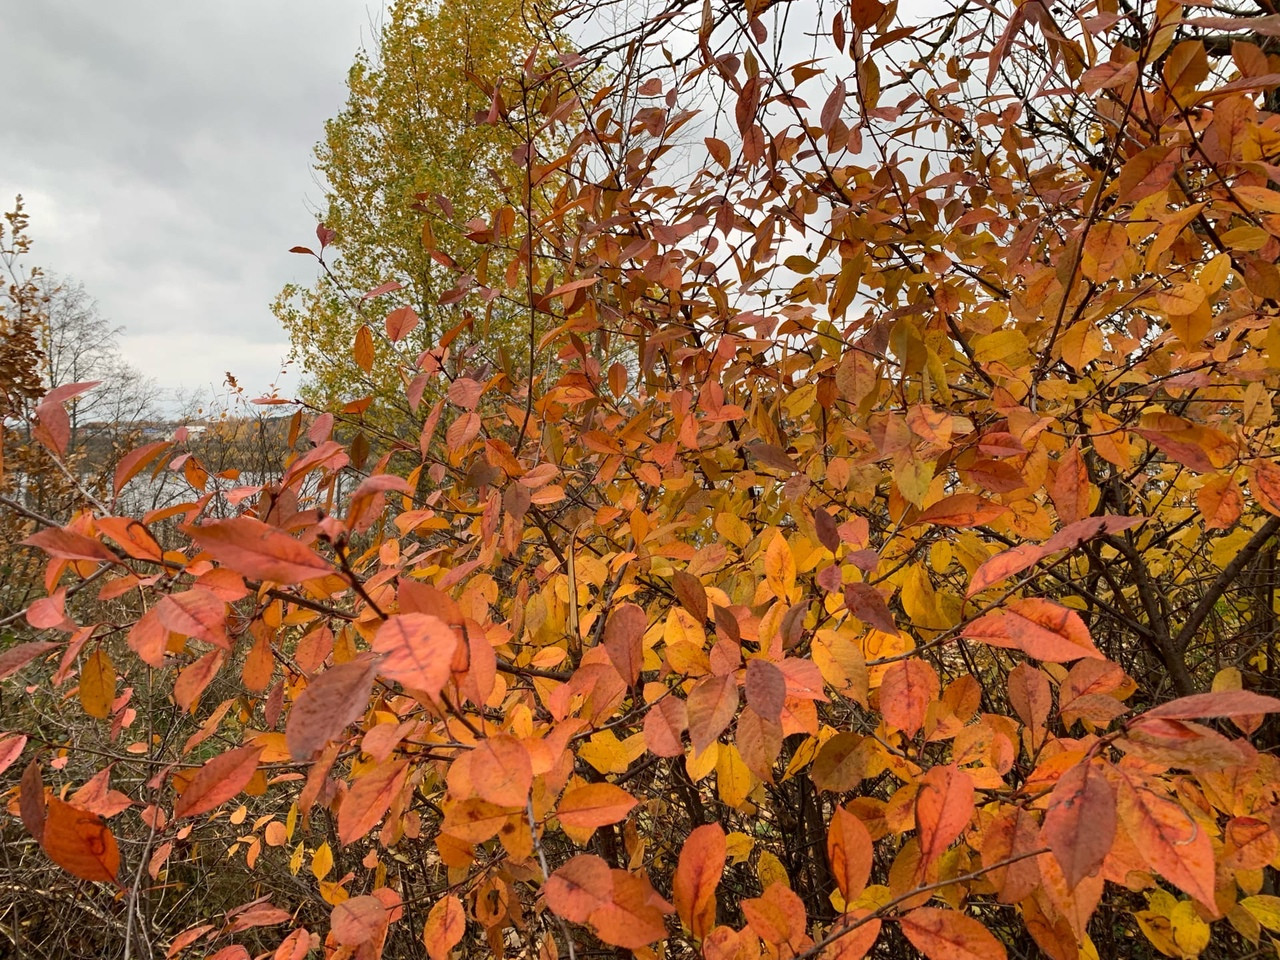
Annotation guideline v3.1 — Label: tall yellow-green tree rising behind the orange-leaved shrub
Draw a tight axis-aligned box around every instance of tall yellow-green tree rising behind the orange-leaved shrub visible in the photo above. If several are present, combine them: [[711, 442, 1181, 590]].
[[274, 0, 555, 421]]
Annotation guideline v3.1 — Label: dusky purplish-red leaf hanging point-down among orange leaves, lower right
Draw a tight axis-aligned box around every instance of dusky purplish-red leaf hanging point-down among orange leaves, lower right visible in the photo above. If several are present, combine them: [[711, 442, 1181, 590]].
[[1041, 762, 1116, 890]]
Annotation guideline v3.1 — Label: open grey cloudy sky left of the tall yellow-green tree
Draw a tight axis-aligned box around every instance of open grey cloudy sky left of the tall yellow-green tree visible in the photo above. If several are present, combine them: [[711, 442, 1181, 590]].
[[0, 0, 381, 409]]
